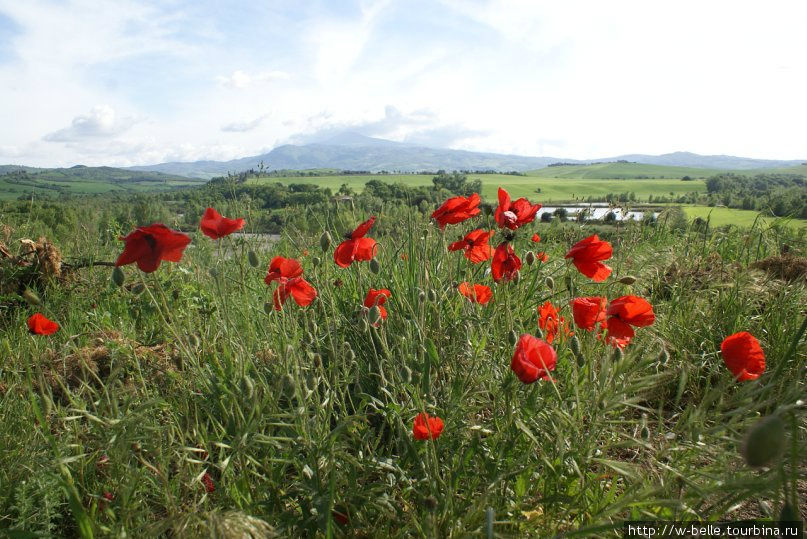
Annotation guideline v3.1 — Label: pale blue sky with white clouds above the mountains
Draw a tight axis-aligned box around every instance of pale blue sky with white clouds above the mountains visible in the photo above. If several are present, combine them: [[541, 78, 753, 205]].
[[0, 0, 807, 166]]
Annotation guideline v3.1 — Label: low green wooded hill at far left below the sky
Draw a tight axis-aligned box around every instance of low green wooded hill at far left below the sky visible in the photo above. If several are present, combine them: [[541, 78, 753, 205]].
[[0, 165, 204, 200]]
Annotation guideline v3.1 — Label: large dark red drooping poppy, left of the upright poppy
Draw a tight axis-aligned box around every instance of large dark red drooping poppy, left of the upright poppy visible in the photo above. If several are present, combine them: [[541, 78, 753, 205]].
[[115, 223, 191, 273]]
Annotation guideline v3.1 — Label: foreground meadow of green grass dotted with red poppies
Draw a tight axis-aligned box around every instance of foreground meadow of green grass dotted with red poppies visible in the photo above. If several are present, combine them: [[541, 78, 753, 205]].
[[0, 188, 807, 537]]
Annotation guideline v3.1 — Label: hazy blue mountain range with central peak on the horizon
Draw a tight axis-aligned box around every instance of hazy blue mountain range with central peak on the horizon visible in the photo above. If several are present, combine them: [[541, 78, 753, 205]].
[[126, 132, 804, 179]]
